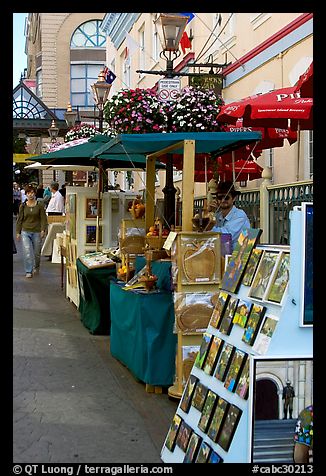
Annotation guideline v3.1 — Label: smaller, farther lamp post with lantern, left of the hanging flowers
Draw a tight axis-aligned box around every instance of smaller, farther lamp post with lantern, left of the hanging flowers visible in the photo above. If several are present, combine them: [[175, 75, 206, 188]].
[[91, 69, 112, 251]]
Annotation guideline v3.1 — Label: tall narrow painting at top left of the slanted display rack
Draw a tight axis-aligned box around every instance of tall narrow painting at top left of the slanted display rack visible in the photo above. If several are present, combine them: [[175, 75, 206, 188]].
[[220, 228, 262, 293]]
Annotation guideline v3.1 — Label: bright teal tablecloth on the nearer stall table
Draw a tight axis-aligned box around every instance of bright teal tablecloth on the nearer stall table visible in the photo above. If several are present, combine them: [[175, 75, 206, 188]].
[[110, 282, 177, 386]]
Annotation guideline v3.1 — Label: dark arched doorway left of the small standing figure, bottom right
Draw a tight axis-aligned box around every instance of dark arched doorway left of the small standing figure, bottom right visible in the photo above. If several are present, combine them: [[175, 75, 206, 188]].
[[255, 379, 279, 420]]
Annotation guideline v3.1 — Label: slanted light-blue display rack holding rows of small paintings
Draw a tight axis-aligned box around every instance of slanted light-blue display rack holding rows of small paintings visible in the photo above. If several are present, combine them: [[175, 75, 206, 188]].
[[161, 207, 312, 463]]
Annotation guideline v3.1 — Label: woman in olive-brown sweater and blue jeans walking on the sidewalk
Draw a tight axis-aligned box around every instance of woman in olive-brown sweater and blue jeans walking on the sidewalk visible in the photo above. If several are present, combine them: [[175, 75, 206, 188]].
[[16, 185, 48, 278]]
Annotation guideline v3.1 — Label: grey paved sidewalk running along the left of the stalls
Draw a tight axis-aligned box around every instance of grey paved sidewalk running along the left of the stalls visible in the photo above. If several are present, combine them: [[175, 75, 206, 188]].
[[13, 219, 178, 464]]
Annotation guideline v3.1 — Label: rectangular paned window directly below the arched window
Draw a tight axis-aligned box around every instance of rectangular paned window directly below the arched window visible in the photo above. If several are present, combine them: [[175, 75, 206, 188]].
[[70, 63, 104, 108]]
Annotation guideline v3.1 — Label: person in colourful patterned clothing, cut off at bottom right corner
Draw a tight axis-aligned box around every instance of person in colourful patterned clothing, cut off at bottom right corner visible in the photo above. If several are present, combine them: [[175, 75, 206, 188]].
[[293, 405, 314, 463]]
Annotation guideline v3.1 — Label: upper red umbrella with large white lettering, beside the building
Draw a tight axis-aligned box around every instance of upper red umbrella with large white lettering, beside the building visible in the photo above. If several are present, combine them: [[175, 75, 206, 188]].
[[217, 87, 313, 129]]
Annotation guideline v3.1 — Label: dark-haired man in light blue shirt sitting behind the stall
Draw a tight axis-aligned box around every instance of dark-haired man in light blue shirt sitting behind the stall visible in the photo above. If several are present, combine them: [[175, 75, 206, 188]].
[[209, 181, 250, 250]]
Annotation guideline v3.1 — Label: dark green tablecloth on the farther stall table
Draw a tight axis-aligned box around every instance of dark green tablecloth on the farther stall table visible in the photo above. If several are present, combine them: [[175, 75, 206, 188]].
[[76, 259, 116, 335]]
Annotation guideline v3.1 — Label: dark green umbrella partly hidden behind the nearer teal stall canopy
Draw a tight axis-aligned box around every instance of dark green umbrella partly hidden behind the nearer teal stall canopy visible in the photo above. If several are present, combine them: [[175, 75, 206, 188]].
[[33, 134, 165, 170]]
